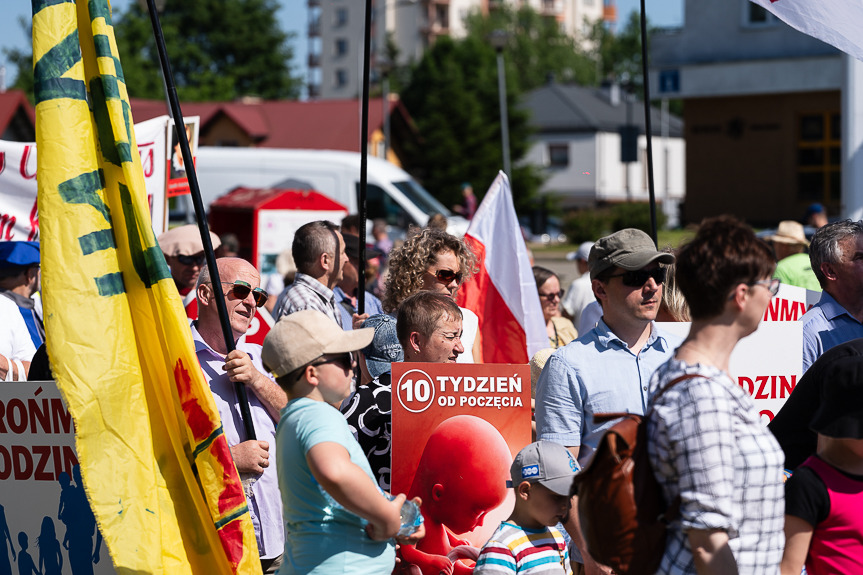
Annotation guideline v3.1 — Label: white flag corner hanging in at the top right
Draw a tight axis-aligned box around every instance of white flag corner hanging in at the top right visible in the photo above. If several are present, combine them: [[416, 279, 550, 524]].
[[752, 0, 863, 60]]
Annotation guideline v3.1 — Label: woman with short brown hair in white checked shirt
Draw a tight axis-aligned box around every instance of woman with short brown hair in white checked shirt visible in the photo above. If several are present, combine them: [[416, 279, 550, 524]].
[[647, 217, 785, 575]]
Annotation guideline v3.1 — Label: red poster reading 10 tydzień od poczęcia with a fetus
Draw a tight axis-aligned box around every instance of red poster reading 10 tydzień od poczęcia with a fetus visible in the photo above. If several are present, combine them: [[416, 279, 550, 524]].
[[392, 363, 531, 574]]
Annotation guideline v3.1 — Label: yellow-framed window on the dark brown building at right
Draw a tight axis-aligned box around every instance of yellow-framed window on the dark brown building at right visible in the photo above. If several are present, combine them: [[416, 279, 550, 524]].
[[797, 112, 842, 203]]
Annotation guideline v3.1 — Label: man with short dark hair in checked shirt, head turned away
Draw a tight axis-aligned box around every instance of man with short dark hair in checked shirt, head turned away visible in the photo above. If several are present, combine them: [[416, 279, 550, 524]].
[[274, 220, 348, 327]]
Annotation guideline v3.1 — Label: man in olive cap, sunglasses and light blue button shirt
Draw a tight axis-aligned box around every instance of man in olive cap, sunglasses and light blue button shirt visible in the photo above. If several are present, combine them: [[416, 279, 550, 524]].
[[536, 229, 682, 575]]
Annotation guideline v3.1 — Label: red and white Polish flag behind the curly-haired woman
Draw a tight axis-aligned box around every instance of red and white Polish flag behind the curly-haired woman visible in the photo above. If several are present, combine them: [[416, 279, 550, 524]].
[[456, 172, 548, 363]]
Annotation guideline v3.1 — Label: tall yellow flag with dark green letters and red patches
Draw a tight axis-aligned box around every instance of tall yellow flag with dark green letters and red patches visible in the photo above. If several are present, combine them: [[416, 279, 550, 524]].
[[32, 0, 261, 575]]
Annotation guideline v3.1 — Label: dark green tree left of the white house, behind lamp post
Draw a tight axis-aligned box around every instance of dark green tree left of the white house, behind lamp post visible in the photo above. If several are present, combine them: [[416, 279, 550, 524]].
[[402, 35, 542, 213]]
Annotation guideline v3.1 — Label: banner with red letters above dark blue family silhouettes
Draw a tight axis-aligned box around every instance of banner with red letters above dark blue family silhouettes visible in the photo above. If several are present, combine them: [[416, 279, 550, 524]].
[[0, 381, 116, 575]]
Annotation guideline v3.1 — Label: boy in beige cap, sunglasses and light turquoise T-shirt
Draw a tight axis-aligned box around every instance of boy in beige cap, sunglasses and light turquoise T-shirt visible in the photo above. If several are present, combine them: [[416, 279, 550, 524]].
[[263, 309, 422, 573]]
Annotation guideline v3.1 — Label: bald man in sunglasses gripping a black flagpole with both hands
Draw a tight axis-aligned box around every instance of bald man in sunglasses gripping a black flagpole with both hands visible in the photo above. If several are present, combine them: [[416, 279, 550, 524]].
[[191, 258, 288, 573]]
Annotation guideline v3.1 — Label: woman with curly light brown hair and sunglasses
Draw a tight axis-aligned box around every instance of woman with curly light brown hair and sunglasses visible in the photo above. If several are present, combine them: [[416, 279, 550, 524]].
[[383, 228, 480, 363]]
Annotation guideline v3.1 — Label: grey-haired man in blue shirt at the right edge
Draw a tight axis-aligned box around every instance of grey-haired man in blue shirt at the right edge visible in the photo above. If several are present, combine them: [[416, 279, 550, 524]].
[[800, 220, 863, 373]]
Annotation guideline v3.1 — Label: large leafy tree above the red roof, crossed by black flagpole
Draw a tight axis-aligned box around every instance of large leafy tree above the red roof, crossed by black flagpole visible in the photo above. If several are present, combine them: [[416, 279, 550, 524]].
[[114, 0, 302, 101]]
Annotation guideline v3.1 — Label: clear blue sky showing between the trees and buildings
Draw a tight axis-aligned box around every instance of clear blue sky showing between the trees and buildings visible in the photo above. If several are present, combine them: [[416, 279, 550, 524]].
[[0, 0, 683, 97]]
